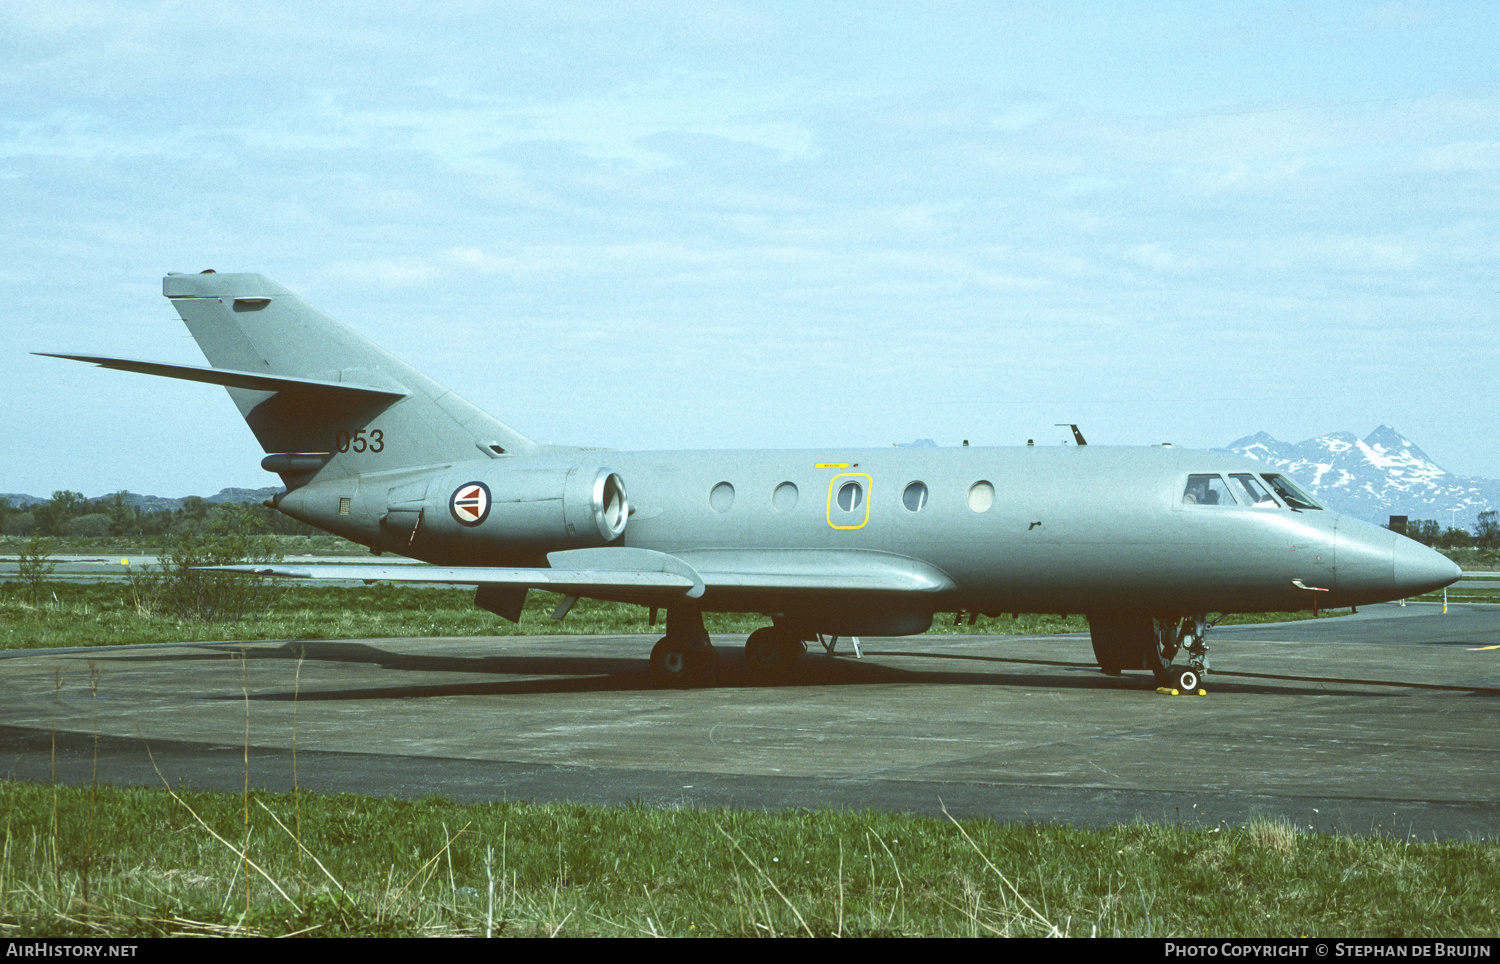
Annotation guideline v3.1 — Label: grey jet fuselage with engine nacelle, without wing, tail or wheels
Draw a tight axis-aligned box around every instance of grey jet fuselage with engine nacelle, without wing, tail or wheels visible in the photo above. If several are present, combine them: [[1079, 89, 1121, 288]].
[[281, 445, 1458, 613]]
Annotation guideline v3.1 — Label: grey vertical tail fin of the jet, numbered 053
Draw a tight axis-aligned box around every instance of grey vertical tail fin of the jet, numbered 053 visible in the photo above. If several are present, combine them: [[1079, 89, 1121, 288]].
[[162, 273, 537, 489]]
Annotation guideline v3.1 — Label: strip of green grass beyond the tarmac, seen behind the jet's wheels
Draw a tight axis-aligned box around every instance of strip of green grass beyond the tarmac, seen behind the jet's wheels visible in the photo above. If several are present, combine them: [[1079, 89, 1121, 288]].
[[0, 582, 1350, 649]]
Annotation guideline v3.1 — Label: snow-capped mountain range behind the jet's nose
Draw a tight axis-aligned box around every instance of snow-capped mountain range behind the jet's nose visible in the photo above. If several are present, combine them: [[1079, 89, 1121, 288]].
[[1227, 426, 1500, 528]]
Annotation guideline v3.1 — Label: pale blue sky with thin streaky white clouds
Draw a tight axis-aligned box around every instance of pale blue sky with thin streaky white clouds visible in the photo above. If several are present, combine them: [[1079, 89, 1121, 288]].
[[0, 0, 1500, 496]]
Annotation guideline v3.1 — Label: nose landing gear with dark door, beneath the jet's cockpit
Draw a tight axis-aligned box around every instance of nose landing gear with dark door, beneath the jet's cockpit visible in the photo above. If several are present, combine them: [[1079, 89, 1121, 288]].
[[1089, 613, 1209, 693]]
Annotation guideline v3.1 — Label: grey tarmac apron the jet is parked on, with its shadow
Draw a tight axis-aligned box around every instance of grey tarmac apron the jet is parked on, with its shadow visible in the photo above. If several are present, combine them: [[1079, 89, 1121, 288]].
[[0, 604, 1500, 840]]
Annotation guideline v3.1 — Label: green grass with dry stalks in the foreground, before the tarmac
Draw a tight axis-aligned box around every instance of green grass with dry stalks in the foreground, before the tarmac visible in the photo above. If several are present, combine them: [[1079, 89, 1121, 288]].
[[0, 783, 1500, 937]]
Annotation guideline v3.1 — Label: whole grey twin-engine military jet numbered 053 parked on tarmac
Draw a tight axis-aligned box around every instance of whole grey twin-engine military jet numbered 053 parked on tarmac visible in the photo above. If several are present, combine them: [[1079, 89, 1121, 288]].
[[43, 271, 1460, 691]]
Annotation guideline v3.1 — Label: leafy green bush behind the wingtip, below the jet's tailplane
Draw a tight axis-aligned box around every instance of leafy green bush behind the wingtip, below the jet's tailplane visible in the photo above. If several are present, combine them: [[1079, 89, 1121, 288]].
[[131, 505, 281, 622]]
